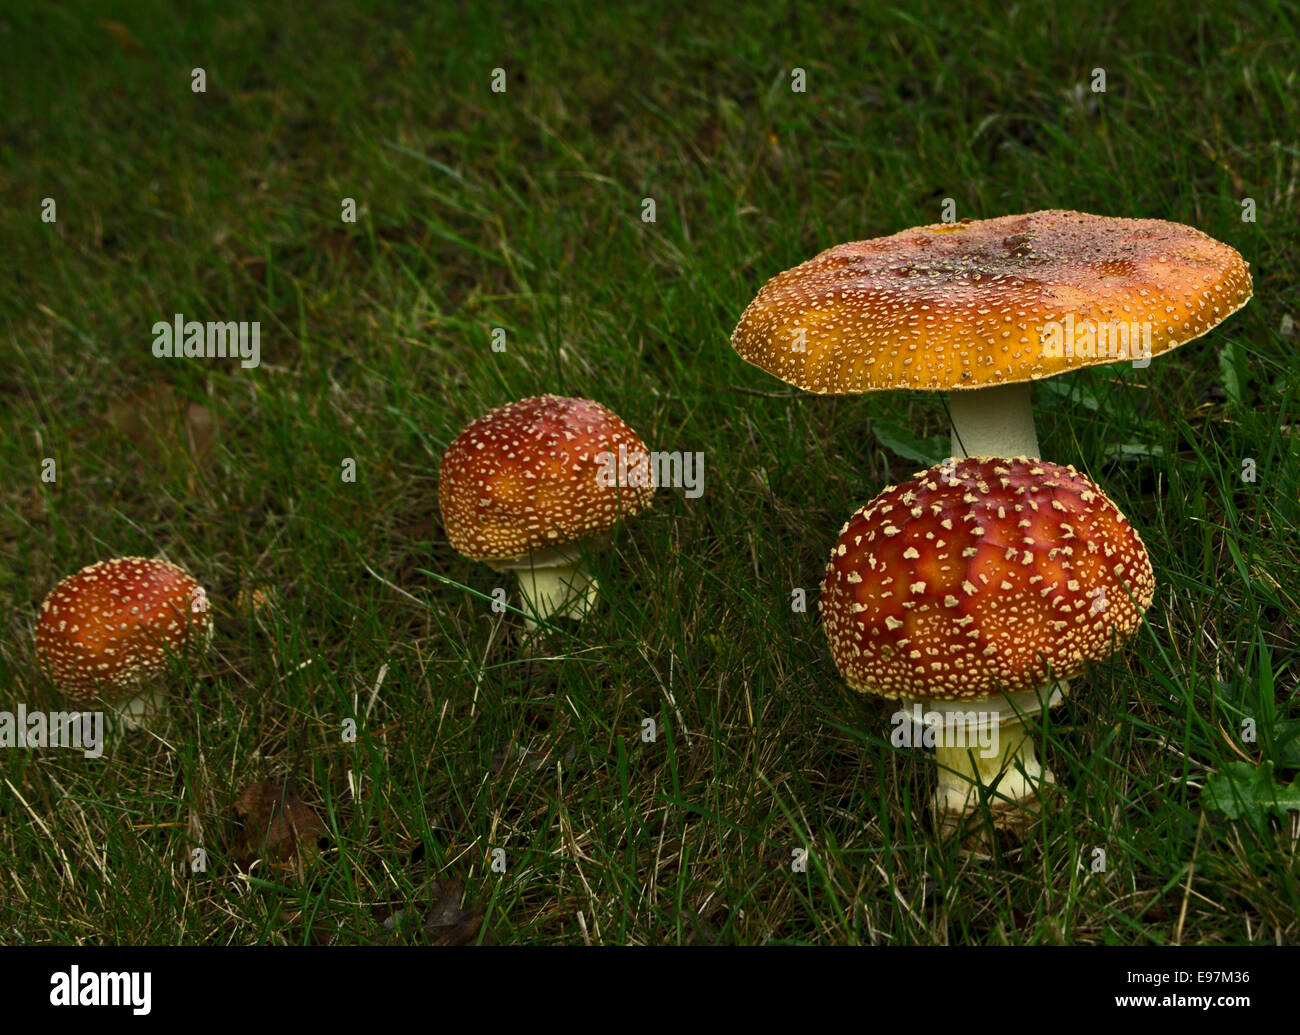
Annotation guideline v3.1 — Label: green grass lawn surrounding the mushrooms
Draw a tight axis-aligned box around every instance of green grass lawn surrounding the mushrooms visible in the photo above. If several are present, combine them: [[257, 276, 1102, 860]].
[[0, 1, 1300, 944]]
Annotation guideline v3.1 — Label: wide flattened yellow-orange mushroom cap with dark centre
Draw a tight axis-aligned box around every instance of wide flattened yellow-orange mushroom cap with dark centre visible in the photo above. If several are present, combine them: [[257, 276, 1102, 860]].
[[732, 211, 1251, 394]]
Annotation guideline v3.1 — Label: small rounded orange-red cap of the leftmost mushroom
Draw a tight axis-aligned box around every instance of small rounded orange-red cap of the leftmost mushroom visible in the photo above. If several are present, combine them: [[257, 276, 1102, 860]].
[[36, 557, 212, 702]]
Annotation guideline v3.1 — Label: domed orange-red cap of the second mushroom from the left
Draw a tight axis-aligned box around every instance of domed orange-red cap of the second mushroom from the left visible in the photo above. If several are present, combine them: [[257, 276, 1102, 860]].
[[438, 395, 654, 560]]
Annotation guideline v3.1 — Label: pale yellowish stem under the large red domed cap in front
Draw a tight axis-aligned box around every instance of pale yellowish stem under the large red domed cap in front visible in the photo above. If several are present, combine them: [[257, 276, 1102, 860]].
[[919, 683, 1067, 827]]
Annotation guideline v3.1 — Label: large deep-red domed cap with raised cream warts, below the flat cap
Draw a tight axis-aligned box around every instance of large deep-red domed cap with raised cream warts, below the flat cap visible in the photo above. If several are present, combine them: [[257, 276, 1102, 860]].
[[820, 456, 1156, 701]]
